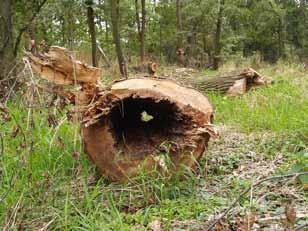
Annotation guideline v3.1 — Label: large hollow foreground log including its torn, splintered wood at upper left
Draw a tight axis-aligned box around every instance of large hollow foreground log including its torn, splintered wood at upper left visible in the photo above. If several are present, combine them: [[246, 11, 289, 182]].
[[28, 48, 216, 181]]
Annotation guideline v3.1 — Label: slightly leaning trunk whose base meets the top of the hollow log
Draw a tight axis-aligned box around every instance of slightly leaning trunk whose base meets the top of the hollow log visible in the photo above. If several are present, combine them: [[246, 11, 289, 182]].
[[109, 0, 127, 78]]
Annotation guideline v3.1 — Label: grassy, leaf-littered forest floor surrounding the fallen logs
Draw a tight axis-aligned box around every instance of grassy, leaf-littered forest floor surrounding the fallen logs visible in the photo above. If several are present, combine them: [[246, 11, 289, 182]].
[[0, 61, 308, 231]]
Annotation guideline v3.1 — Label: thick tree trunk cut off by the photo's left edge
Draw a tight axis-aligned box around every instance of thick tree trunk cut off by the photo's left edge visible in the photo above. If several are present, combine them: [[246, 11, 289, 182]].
[[0, 0, 15, 98]]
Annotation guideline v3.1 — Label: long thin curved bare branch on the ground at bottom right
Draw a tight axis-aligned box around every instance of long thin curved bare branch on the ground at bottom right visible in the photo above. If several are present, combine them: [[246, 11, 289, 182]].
[[204, 172, 308, 231]]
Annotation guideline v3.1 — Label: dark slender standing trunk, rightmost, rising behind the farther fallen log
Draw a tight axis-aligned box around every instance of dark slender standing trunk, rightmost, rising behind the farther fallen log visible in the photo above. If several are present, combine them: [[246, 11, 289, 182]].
[[213, 0, 225, 70]]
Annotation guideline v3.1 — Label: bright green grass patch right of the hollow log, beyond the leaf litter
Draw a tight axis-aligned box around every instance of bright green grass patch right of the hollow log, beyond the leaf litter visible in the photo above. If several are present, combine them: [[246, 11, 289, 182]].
[[208, 66, 308, 137]]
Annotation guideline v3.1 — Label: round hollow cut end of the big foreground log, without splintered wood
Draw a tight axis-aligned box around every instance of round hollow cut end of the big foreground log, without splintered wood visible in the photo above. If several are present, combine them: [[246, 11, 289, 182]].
[[83, 79, 215, 181]]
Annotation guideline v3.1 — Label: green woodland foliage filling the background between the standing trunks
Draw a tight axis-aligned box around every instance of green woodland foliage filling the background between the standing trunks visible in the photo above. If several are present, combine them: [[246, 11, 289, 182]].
[[10, 0, 308, 65]]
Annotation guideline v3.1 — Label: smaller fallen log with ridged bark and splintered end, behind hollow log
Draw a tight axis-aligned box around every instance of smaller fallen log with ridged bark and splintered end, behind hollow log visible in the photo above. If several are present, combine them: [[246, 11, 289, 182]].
[[191, 68, 270, 96]]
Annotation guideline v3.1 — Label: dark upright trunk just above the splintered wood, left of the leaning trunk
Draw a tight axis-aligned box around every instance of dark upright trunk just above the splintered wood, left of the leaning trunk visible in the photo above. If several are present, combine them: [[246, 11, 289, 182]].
[[87, 0, 97, 67]]
